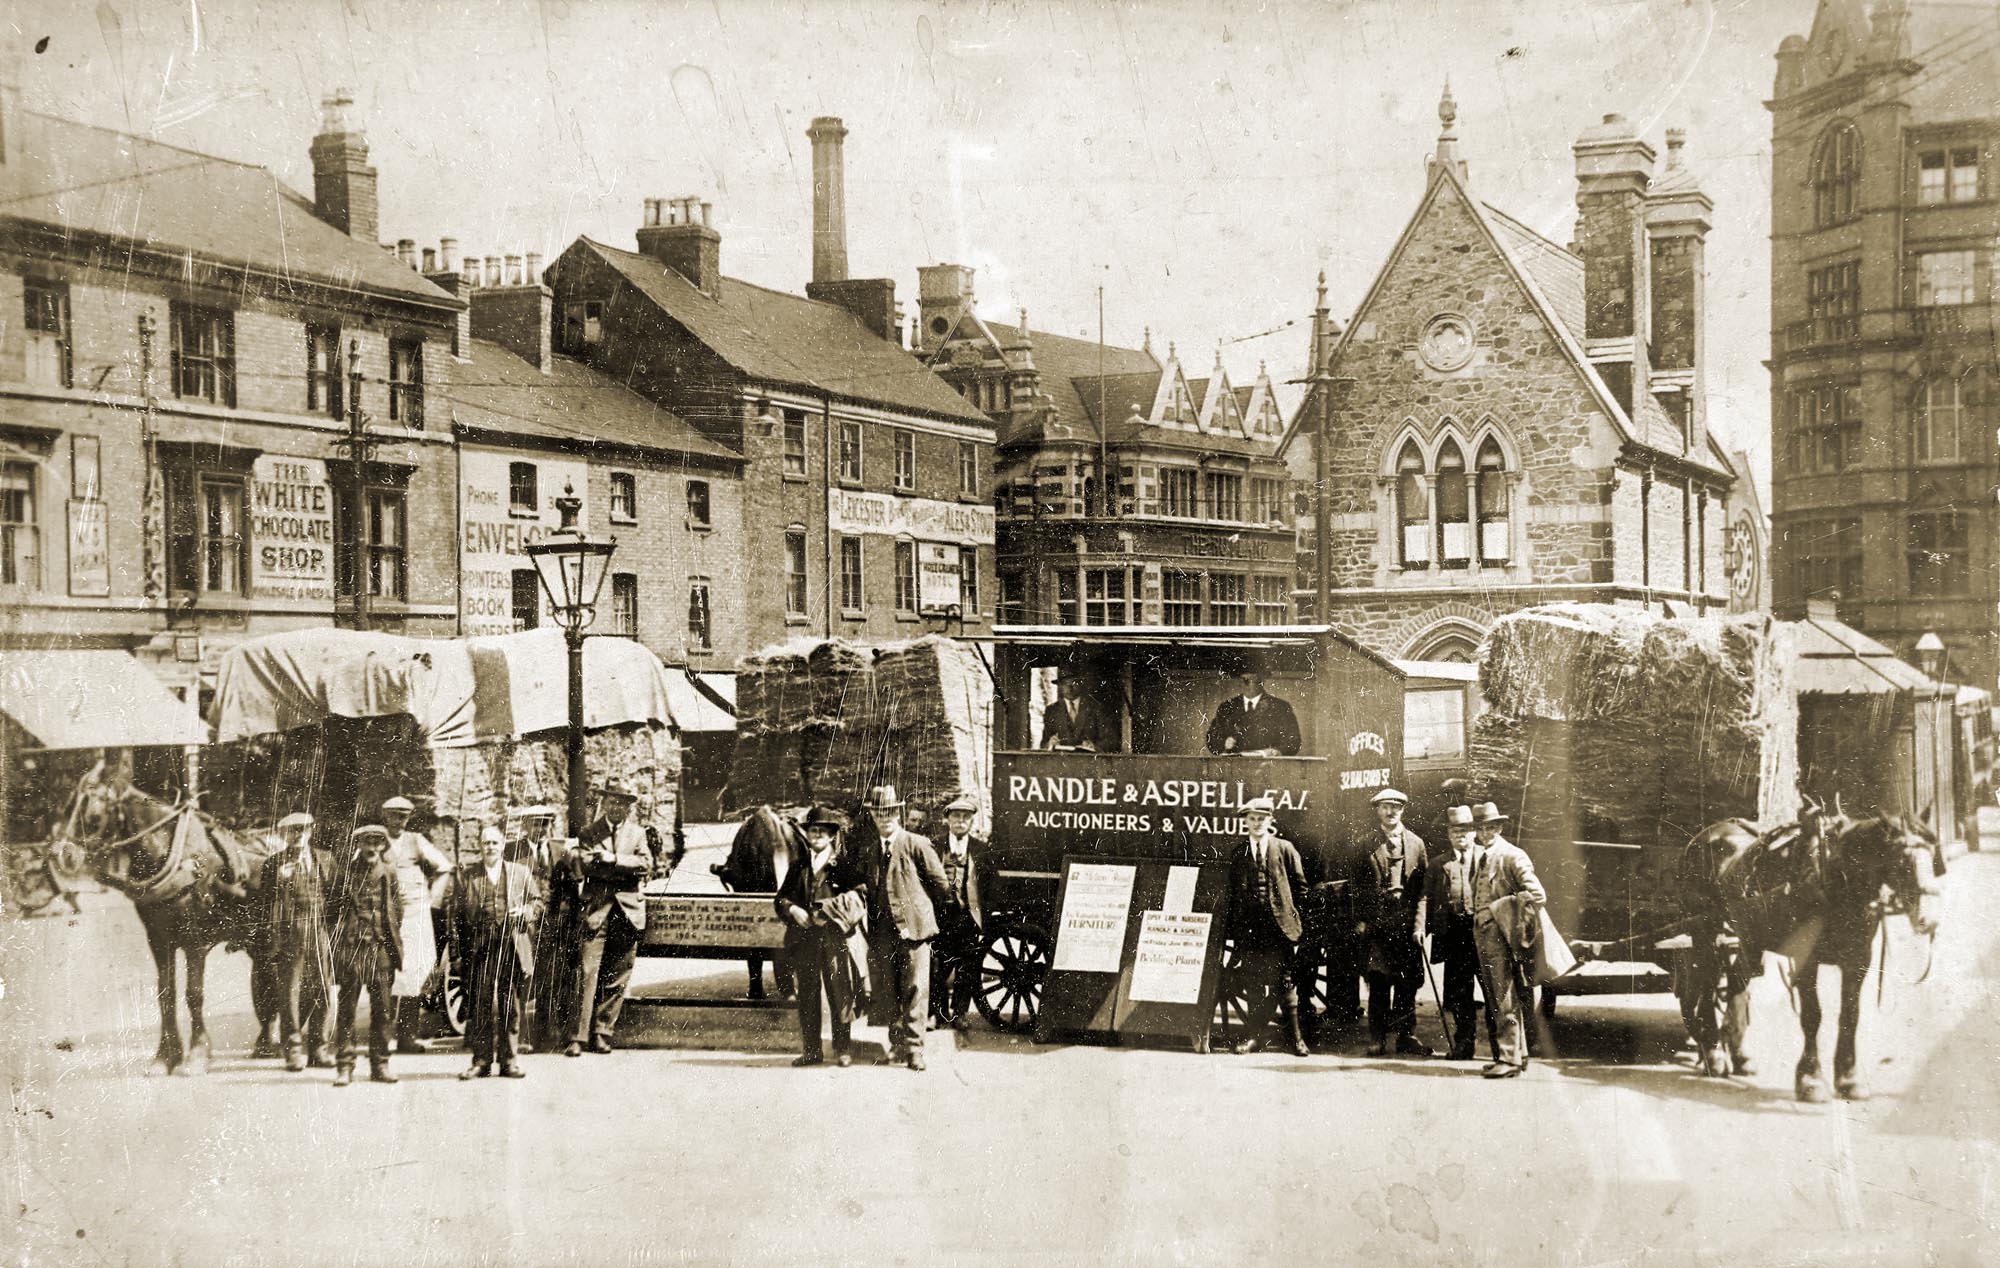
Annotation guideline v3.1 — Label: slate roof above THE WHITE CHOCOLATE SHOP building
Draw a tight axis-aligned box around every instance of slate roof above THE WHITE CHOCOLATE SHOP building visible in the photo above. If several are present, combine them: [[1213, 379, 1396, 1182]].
[[0, 112, 460, 308]]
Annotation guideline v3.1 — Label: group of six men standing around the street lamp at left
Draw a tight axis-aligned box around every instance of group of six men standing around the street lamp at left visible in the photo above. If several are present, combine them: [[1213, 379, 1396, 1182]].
[[256, 782, 676, 1086]]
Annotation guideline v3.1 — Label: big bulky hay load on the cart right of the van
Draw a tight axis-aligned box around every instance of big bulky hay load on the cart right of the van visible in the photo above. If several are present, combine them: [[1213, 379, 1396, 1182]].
[[1470, 604, 1798, 990]]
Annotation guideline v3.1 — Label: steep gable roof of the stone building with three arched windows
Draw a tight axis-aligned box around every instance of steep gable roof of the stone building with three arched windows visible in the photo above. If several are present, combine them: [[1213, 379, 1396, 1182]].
[[1280, 164, 1730, 476]]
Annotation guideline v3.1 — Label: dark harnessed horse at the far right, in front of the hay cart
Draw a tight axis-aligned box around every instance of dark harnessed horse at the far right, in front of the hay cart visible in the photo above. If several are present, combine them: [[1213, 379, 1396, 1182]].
[[1678, 802, 1944, 1102]]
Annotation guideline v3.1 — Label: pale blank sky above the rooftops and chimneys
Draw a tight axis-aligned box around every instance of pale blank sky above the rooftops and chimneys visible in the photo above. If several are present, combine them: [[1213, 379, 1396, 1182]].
[[14, 0, 1814, 494]]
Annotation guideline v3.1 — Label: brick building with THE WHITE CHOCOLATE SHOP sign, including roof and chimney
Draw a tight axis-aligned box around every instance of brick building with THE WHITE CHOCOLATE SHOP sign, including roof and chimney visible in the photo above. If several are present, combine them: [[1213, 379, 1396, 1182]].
[[0, 84, 464, 706]]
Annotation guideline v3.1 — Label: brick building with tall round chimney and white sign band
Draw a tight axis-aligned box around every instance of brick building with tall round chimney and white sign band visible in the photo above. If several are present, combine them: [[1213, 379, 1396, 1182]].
[[546, 118, 994, 648]]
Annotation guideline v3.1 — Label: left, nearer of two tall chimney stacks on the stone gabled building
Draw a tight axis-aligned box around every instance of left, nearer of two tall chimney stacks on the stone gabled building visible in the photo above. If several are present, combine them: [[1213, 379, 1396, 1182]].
[[1570, 114, 1654, 410]]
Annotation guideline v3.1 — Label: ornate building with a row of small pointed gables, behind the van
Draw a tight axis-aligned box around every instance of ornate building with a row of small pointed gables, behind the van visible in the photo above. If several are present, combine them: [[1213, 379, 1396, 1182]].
[[918, 264, 1294, 626]]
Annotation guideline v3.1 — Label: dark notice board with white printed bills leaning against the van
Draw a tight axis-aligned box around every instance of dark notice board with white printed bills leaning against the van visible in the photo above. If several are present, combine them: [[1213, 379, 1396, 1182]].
[[1038, 856, 1230, 1050]]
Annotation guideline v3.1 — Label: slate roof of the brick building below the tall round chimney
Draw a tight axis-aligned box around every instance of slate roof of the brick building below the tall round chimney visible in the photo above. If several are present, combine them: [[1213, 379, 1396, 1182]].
[[580, 238, 992, 426]]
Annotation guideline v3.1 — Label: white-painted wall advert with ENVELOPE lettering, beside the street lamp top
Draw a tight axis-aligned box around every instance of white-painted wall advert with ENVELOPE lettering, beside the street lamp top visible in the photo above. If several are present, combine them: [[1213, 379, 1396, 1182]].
[[458, 446, 590, 634]]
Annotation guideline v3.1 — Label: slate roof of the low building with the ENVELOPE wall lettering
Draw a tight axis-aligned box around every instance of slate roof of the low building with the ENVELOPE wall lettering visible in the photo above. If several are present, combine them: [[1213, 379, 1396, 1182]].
[[446, 340, 742, 462]]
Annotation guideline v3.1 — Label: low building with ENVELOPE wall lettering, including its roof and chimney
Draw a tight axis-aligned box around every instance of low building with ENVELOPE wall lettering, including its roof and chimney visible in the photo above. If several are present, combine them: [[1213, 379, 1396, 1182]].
[[440, 256, 752, 670]]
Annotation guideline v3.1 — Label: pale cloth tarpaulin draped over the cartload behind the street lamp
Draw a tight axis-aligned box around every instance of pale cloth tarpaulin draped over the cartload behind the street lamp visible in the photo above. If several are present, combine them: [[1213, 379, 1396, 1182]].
[[208, 628, 672, 748]]
